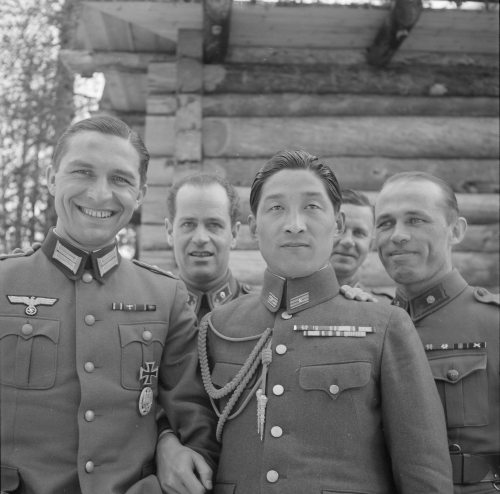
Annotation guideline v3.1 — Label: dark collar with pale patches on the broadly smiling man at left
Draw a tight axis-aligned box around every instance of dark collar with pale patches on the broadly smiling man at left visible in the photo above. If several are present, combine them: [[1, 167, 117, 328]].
[[42, 228, 121, 283]]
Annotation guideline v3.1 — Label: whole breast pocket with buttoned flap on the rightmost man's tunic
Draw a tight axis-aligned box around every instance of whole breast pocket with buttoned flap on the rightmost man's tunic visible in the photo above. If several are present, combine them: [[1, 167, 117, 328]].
[[429, 352, 489, 427]]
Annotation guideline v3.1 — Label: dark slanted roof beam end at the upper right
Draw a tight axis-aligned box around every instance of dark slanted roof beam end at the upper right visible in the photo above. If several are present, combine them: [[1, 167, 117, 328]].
[[366, 0, 423, 67]]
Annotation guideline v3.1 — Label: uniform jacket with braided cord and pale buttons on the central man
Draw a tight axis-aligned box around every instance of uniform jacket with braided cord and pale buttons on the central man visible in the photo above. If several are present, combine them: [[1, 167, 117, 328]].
[[199, 266, 453, 494]]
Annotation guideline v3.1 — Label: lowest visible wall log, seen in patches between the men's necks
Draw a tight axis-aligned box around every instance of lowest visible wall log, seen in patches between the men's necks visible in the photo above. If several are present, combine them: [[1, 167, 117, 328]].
[[140, 250, 499, 288]]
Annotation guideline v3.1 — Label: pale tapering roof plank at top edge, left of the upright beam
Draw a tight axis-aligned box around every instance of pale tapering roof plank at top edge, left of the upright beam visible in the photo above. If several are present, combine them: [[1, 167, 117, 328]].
[[84, 1, 203, 41]]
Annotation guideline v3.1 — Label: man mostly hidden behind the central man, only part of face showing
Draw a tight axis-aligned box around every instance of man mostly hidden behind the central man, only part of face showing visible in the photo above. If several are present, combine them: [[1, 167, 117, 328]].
[[330, 189, 394, 303]]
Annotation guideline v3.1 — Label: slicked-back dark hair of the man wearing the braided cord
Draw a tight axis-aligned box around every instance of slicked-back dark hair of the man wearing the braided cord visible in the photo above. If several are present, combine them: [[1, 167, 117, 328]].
[[250, 150, 342, 216]]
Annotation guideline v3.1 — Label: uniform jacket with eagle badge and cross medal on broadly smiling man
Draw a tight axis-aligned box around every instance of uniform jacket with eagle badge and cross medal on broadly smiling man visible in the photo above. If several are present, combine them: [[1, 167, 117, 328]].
[[0, 232, 218, 494]]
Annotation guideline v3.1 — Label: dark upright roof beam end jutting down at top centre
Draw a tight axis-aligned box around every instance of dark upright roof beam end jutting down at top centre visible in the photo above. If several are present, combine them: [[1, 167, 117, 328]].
[[203, 0, 233, 63]]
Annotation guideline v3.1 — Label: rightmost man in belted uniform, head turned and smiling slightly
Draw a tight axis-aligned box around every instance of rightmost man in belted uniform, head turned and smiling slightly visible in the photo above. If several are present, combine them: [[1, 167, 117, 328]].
[[375, 172, 500, 494]]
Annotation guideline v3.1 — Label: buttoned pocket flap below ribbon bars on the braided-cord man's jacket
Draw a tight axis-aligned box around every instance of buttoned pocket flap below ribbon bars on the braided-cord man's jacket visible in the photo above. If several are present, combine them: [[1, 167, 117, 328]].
[[299, 362, 372, 396]]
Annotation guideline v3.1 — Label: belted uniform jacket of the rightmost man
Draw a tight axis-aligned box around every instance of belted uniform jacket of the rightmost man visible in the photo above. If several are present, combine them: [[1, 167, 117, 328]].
[[394, 270, 500, 493]]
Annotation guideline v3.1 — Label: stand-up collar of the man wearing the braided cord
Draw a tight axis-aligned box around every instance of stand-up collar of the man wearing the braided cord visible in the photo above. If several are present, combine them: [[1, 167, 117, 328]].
[[260, 264, 339, 314]]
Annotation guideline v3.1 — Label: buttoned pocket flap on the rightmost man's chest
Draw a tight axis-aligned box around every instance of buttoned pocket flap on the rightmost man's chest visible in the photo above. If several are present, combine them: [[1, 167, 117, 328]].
[[429, 353, 487, 384]]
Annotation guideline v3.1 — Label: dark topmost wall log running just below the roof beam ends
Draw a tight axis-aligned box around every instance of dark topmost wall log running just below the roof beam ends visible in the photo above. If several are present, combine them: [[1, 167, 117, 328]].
[[204, 64, 499, 97]]
